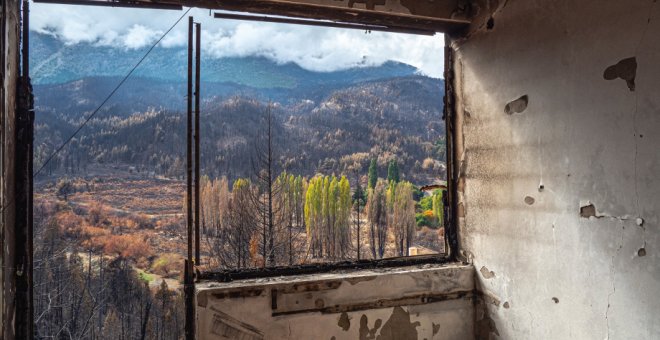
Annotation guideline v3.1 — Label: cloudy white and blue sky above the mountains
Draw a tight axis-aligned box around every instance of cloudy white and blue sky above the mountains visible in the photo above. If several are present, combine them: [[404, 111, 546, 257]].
[[30, 3, 444, 78]]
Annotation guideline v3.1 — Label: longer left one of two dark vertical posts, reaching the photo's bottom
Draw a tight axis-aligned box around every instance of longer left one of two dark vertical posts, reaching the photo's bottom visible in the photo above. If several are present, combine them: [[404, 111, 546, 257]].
[[184, 17, 195, 340]]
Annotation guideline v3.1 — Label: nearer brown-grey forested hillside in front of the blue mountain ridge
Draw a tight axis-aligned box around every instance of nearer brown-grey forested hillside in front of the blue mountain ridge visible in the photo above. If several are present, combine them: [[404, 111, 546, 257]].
[[35, 76, 444, 183]]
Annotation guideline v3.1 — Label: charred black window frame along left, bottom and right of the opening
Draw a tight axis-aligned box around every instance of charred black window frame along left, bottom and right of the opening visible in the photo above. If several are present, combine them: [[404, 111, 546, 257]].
[[11, 0, 459, 338]]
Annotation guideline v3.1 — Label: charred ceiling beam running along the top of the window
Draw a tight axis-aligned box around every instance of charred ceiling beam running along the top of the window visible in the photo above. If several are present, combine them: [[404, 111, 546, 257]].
[[33, 0, 470, 34]]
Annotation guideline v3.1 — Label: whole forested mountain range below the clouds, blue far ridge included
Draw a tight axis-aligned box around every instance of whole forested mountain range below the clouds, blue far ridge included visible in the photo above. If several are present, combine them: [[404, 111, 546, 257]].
[[30, 33, 444, 182]]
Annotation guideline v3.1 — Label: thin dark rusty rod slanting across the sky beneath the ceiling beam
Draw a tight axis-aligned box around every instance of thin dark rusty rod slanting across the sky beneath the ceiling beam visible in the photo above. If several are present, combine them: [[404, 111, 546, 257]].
[[213, 12, 435, 35]]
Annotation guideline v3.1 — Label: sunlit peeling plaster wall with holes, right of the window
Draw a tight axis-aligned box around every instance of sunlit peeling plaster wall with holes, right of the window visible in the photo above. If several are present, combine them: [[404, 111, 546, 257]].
[[452, 0, 660, 339]]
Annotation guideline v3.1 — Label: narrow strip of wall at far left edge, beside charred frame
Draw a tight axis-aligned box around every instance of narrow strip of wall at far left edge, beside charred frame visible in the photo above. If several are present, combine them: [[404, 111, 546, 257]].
[[0, 0, 20, 340]]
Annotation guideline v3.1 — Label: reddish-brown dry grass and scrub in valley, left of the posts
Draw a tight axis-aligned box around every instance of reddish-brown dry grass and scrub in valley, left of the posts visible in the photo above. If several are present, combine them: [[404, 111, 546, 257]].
[[35, 176, 186, 277]]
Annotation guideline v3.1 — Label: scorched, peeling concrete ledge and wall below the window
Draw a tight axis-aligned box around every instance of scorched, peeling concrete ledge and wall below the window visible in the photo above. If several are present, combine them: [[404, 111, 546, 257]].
[[196, 264, 475, 340]]
